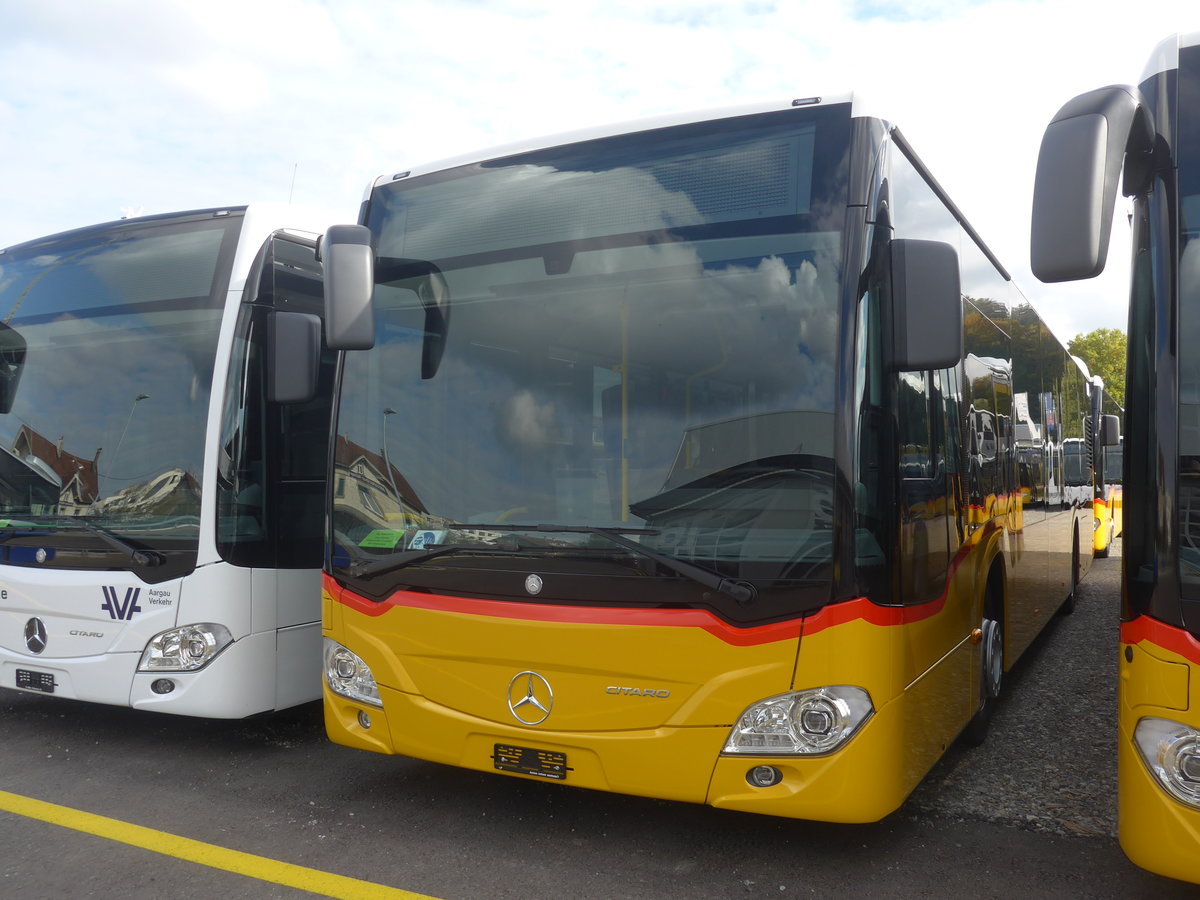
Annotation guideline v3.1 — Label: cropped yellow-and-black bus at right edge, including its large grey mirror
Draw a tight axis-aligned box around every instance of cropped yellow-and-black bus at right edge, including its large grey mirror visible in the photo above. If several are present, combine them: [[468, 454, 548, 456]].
[[1031, 35, 1200, 883]]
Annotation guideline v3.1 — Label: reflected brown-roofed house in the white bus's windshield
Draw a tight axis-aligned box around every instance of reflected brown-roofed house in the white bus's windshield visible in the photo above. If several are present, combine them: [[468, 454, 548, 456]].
[[0, 425, 100, 516]]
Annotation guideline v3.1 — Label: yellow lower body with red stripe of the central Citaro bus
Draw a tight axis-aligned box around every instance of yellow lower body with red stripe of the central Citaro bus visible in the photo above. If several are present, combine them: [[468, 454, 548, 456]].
[[324, 535, 980, 822]]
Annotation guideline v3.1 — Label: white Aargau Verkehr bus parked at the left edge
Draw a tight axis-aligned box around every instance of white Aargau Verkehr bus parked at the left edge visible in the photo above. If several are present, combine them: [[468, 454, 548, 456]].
[[0, 205, 332, 718]]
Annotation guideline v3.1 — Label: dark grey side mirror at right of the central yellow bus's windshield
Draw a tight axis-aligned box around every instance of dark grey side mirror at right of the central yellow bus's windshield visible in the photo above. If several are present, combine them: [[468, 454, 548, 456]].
[[890, 239, 962, 372]]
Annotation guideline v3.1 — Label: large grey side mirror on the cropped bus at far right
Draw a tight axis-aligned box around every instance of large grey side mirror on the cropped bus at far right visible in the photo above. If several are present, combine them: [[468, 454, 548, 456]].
[[1030, 85, 1153, 282]]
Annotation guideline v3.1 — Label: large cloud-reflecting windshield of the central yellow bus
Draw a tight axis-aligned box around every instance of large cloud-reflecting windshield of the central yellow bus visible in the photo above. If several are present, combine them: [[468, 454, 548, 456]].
[[334, 107, 848, 614]]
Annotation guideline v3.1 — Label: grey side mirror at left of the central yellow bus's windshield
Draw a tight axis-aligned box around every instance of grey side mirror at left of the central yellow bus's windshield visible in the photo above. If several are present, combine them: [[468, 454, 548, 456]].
[[318, 226, 374, 350]]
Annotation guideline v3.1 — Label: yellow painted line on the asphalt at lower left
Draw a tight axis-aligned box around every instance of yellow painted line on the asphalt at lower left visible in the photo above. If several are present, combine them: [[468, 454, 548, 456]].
[[0, 791, 433, 900]]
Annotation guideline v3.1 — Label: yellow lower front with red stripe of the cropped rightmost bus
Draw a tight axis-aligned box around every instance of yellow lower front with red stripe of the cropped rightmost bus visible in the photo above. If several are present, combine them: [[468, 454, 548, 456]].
[[1117, 617, 1200, 884]]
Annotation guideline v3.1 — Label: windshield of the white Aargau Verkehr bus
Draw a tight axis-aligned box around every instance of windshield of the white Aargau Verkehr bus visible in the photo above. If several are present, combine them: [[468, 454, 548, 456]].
[[0, 216, 241, 568]]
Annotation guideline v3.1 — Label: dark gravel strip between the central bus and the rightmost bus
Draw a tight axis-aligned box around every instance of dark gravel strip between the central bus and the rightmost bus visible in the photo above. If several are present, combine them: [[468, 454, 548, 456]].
[[901, 539, 1121, 838]]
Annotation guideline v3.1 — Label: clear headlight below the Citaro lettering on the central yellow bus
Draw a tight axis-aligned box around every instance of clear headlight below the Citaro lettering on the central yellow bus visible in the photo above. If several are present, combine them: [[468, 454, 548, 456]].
[[725, 685, 875, 756]]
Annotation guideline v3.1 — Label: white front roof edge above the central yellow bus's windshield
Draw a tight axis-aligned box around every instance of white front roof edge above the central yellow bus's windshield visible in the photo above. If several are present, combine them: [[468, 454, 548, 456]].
[[366, 92, 866, 194]]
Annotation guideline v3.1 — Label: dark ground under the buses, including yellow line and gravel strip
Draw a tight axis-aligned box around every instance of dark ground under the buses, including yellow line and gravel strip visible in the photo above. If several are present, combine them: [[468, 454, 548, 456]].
[[0, 542, 1200, 900]]
